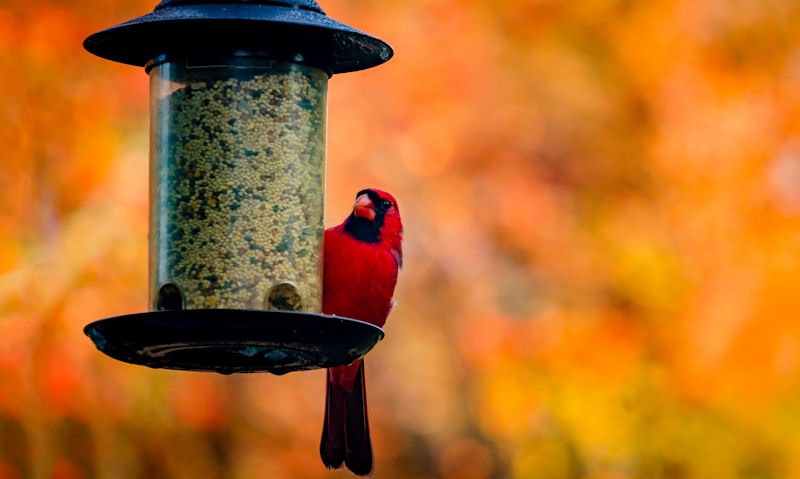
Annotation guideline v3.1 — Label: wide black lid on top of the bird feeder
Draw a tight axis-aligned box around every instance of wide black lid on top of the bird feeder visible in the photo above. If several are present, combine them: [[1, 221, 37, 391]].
[[83, 0, 393, 74]]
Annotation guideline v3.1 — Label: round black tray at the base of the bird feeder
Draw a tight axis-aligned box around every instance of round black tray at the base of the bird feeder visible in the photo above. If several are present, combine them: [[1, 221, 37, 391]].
[[83, 309, 384, 375]]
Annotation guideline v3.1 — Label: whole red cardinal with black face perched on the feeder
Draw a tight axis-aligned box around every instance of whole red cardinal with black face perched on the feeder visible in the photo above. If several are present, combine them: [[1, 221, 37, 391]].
[[319, 189, 403, 476]]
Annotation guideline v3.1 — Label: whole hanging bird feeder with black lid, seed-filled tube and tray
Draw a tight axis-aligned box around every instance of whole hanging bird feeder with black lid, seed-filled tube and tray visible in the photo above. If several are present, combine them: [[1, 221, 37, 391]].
[[84, 0, 392, 374]]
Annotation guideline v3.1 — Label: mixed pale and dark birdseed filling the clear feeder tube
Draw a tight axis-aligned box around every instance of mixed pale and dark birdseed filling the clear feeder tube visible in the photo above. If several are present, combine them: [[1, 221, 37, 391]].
[[151, 64, 327, 312]]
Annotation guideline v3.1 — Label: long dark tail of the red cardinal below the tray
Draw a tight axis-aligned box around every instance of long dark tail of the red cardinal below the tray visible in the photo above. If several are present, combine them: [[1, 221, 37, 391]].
[[319, 361, 373, 476]]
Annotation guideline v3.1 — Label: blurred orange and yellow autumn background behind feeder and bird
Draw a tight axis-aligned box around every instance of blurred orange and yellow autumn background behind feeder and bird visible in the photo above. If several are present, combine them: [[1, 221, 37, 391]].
[[0, 0, 800, 479]]
